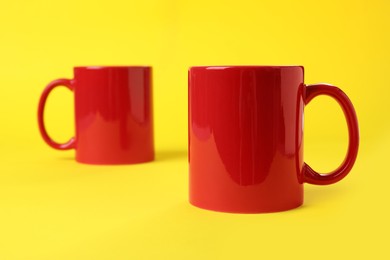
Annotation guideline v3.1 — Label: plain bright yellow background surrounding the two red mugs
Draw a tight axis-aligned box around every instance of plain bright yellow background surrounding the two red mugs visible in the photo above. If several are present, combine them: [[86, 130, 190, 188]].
[[0, 0, 390, 260]]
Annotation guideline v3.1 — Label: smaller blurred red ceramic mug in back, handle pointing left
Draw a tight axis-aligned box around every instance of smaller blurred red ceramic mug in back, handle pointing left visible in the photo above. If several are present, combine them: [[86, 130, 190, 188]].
[[38, 66, 154, 164]]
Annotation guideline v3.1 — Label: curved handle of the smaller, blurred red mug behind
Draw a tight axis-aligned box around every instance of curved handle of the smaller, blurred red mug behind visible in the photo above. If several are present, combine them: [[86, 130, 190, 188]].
[[38, 79, 75, 150]]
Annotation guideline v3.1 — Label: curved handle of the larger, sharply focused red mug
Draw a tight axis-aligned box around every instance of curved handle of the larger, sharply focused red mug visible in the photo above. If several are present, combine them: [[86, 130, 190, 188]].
[[303, 84, 359, 185]]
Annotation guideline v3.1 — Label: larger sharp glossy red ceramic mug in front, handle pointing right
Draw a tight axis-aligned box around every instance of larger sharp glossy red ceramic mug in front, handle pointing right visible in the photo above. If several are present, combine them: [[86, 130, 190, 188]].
[[188, 66, 359, 213]]
